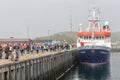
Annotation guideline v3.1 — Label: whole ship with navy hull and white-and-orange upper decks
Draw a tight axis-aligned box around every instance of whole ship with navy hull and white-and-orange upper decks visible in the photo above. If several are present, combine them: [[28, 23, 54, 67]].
[[77, 6, 111, 65]]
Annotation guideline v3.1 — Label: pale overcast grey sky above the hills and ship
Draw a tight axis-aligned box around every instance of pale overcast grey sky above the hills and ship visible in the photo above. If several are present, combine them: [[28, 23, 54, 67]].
[[0, 0, 120, 38]]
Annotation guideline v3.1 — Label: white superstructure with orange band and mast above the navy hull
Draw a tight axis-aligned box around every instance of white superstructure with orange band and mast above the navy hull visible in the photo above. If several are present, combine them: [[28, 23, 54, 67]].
[[77, 7, 111, 48]]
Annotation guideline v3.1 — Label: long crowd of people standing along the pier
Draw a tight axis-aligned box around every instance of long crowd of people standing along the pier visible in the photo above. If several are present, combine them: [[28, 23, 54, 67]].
[[0, 43, 74, 60]]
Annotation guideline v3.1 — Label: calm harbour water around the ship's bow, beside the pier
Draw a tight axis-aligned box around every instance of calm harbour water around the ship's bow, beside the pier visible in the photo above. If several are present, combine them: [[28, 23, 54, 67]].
[[62, 53, 120, 80]]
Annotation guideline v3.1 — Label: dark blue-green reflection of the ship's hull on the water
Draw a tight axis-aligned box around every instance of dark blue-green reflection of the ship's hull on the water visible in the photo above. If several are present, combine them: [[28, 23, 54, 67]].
[[78, 64, 110, 80]]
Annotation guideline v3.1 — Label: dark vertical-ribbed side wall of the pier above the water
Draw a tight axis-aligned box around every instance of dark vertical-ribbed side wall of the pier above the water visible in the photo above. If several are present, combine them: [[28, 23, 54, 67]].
[[0, 50, 77, 80]]
